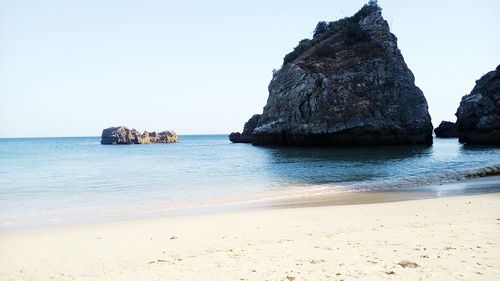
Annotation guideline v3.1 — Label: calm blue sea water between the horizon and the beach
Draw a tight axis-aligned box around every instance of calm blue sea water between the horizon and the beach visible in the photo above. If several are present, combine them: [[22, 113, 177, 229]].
[[0, 135, 500, 228]]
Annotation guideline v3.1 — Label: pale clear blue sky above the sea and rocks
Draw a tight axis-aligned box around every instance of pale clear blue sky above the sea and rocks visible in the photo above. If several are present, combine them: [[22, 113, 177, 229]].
[[0, 0, 500, 137]]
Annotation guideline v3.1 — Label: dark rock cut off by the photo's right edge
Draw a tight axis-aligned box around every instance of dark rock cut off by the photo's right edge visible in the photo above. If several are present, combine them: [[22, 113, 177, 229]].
[[455, 65, 500, 145]]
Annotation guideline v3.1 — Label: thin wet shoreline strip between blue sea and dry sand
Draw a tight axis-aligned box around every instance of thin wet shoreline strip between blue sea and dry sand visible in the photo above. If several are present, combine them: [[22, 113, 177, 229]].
[[0, 175, 500, 233]]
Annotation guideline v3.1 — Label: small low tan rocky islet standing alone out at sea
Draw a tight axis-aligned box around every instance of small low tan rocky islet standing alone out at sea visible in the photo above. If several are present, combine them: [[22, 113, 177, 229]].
[[101, 126, 177, 144]]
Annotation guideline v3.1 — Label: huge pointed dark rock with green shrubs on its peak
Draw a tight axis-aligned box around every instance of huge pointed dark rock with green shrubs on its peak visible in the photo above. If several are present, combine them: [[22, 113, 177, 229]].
[[239, 1, 432, 145]]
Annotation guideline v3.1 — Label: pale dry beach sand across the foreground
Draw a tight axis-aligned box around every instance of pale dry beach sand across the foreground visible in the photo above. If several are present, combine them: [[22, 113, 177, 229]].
[[0, 193, 500, 281]]
